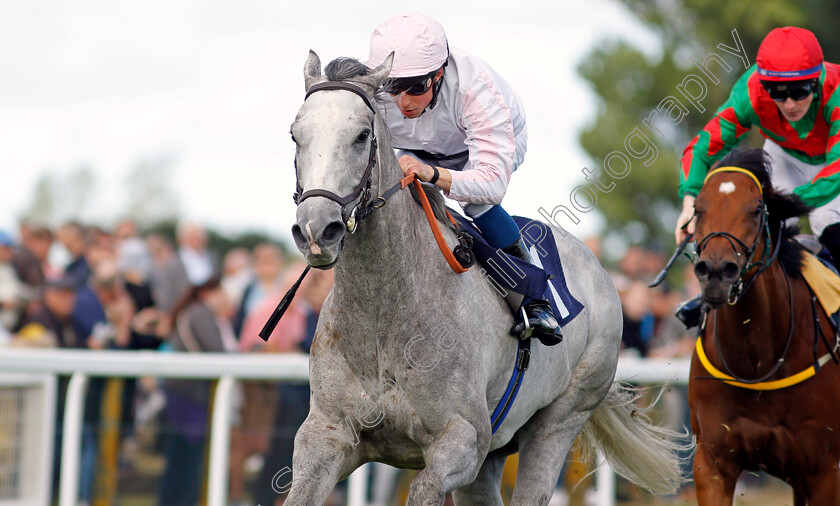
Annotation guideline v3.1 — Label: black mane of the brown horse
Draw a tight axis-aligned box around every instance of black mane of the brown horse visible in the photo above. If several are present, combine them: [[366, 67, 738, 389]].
[[715, 149, 811, 277]]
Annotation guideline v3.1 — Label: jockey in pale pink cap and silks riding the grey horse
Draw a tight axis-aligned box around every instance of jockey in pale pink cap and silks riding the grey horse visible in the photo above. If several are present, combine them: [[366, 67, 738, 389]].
[[365, 13, 562, 345]]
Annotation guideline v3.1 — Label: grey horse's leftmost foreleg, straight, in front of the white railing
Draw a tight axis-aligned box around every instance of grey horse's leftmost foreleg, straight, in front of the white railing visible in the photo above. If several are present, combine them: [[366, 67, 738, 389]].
[[283, 412, 360, 506]]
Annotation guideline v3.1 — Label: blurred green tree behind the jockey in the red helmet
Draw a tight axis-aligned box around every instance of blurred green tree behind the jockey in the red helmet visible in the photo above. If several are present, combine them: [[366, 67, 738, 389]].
[[578, 0, 840, 248]]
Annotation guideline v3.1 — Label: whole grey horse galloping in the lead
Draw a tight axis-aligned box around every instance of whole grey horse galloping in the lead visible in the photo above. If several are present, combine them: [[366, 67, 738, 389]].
[[284, 52, 681, 506]]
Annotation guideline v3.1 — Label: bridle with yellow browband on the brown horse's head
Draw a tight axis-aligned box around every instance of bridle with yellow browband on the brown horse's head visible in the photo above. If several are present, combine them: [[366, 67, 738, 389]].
[[694, 167, 782, 304]]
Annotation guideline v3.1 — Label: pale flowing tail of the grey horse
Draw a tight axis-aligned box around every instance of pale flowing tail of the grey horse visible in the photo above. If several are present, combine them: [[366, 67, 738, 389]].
[[580, 382, 694, 494]]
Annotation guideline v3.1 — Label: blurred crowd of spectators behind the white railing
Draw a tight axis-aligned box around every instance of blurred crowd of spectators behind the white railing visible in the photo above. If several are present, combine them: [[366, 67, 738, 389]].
[[0, 221, 332, 505]]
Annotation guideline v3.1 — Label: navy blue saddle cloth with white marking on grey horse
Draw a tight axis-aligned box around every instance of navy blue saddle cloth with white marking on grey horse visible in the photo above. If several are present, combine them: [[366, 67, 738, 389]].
[[451, 212, 584, 326]]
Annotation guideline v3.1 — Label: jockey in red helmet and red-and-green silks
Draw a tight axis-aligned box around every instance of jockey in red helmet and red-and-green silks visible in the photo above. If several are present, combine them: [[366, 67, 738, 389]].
[[675, 26, 840, 324]]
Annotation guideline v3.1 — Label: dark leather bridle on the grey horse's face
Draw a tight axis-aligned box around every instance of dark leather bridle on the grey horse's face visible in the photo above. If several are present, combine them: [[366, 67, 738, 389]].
[[292, 81, 377, 234]]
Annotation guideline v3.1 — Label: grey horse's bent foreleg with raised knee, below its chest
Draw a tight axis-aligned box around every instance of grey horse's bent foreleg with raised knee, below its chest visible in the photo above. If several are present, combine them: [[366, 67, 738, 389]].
[[406, 416, 490, 506]]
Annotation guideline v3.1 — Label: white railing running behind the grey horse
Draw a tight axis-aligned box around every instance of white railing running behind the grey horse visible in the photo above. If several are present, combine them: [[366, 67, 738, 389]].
[[0, 349, 689, 506]]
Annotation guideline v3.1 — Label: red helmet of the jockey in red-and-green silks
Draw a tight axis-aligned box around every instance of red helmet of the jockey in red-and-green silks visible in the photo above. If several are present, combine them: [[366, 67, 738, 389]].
[[756, 26, 823, 81]]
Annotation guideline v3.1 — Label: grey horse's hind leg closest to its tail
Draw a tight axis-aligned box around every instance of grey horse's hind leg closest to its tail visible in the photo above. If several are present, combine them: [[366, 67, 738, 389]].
[[510, 408, 591, 506]]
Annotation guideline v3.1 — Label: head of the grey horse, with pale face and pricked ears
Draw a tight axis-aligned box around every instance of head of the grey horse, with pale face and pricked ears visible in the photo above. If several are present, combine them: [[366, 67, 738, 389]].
[[291, 51, 393, 269]]
